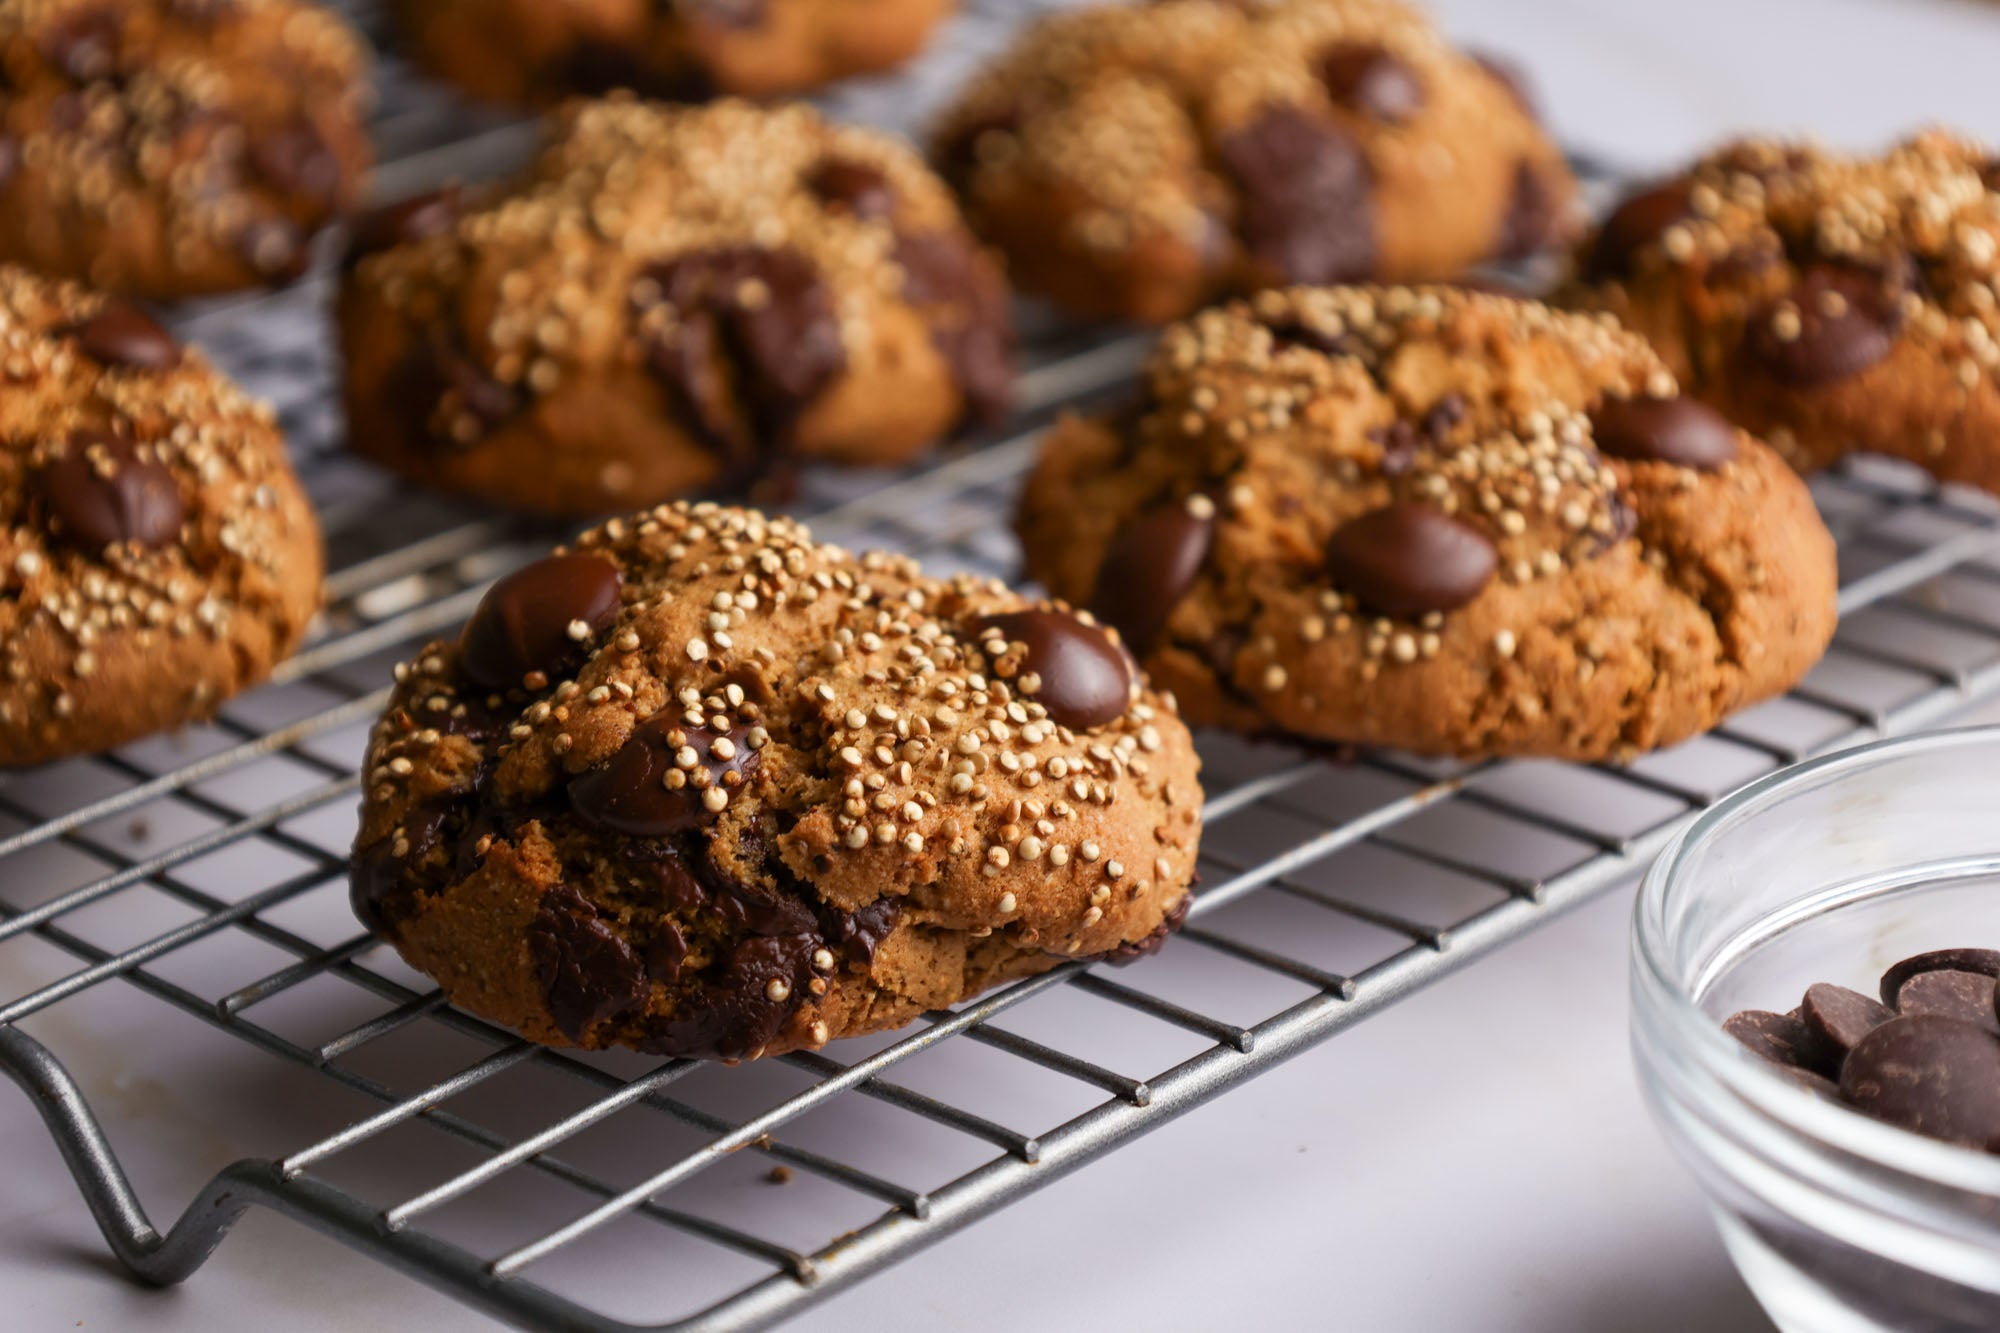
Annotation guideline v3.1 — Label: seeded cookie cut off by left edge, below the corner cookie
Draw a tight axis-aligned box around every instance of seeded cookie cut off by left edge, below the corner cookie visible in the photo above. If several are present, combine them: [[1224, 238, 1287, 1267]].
[[0, 264, 320, 767]]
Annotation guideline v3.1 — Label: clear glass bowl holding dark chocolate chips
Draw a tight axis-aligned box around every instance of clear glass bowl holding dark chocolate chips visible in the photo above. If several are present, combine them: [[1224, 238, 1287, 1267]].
[[1632, 729, 2000, 1333]]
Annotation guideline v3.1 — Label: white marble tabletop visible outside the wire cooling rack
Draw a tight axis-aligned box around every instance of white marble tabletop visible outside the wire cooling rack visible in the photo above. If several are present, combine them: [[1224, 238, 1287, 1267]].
[[11, 0, 2000, 1333]]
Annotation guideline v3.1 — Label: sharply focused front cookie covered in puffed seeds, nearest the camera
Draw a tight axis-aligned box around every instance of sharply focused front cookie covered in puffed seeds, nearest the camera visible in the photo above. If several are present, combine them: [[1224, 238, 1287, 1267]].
[[354, 502, 1202, 1059]]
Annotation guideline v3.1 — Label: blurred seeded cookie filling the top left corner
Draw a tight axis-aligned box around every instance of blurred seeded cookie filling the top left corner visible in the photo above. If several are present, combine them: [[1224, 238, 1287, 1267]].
[[0, 0, 370, 300]]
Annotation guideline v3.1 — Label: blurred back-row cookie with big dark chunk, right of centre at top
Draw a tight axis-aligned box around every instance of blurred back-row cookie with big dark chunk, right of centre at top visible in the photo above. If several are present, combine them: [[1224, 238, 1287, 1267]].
[[936, 0, 1574, 322]]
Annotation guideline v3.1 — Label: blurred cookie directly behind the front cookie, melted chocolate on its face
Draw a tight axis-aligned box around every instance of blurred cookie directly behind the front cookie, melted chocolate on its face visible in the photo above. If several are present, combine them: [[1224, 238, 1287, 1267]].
[[340, 96, 1012, 514]]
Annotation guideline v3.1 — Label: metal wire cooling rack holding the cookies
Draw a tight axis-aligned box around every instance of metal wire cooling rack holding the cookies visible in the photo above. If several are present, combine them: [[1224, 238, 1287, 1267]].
[[11, 6, 2000, 1329]]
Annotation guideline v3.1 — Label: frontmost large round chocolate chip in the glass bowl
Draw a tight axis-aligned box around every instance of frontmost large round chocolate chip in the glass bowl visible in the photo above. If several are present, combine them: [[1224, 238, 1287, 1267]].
[[1840, 1015, 2000, 1149]]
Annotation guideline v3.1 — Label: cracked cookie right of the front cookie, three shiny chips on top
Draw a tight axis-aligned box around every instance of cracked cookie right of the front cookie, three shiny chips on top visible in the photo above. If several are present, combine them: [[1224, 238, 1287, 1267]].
[[1020, 286, 1836, 761]]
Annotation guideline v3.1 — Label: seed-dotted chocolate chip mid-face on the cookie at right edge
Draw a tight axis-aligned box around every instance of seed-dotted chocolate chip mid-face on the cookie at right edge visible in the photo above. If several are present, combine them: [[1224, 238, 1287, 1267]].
[[1744, 262, 1910, 388]]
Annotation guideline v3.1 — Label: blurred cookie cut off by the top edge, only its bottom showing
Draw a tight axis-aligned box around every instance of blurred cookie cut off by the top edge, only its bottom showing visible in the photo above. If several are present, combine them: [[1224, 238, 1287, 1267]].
[[390, 0, 952, 104]]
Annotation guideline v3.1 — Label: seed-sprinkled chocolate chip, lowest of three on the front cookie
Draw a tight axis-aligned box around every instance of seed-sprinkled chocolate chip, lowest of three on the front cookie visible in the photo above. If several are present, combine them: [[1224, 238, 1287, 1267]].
[[570, 713, 756, 839]]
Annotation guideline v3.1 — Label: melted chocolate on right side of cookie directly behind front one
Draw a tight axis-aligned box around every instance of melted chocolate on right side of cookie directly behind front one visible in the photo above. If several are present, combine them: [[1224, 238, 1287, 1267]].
[[896, 232, 1014, 424]]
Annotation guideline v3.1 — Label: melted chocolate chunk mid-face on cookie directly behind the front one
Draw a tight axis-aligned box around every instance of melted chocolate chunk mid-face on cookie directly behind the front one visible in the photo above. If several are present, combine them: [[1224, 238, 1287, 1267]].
[[646, 246, 846, 484]]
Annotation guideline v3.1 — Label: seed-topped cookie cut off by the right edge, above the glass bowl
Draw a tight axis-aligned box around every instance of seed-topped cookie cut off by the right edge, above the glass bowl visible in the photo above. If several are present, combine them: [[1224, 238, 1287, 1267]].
[[1564, 132, 2000, 490]]
